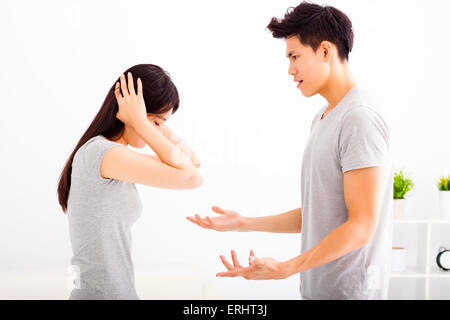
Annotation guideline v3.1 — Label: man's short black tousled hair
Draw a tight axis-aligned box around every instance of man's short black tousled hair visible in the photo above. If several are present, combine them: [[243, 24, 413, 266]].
[[267, 1, 353, 61]]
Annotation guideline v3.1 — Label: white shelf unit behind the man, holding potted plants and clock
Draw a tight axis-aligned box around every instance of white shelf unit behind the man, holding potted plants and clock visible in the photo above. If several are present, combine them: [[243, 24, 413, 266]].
[[389, 219, 450, 300]]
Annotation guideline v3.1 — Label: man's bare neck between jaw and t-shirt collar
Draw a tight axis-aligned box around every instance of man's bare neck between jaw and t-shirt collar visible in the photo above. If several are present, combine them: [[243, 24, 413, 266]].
[[319, 64, 356, 112]]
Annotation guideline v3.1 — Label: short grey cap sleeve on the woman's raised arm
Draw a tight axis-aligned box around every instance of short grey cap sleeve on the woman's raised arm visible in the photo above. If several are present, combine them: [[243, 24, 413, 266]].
[[83, 139, 120, 183]]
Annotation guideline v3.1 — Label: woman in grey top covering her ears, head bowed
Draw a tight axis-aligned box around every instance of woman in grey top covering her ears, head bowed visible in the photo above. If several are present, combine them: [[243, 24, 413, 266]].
[[58, 64, 203, 299]]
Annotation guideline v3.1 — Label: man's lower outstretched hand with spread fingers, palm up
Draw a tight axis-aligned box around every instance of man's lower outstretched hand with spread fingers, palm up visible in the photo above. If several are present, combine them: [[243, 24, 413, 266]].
[[216, 250, 289, 280]]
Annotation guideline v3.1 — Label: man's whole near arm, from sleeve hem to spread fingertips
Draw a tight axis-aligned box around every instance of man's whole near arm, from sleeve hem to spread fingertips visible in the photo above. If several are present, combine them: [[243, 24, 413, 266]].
[[217, 167, 386, 280]]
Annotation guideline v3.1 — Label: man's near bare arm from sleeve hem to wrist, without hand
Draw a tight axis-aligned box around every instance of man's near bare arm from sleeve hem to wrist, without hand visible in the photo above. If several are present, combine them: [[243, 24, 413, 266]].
[[282, 167, 386, 276]]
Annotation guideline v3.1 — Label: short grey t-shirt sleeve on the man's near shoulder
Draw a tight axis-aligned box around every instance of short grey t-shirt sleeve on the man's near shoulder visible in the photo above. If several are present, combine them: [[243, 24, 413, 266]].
[[338, 107, 389, 173]]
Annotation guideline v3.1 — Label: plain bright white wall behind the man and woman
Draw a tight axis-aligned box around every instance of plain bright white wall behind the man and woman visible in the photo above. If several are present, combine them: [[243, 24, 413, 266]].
[[0, 0, 450, 299]]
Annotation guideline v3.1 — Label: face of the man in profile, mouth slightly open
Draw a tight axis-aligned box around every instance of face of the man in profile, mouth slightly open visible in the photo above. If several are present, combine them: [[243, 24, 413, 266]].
[[286, 36, 330, 97]]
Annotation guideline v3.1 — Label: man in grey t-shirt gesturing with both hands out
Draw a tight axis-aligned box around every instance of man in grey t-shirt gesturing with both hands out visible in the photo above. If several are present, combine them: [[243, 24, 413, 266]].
[[187, 2, 393, 299]]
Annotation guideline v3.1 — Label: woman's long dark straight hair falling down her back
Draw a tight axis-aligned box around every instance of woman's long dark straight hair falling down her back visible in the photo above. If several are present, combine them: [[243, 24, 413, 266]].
[[57, 64, 180, 213]]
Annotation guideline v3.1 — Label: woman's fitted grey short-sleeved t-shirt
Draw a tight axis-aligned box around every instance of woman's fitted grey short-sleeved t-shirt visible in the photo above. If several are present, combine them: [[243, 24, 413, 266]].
[[67, 135, 142, 300]]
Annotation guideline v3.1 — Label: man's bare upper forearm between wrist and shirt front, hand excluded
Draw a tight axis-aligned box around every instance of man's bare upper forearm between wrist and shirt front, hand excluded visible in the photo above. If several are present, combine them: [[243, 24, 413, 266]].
[[242, 208, 302, 233]]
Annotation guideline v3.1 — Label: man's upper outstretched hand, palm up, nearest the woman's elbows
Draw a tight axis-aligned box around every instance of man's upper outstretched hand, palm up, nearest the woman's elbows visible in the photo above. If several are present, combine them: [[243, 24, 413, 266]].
[[186, 206, 246, 231]]
